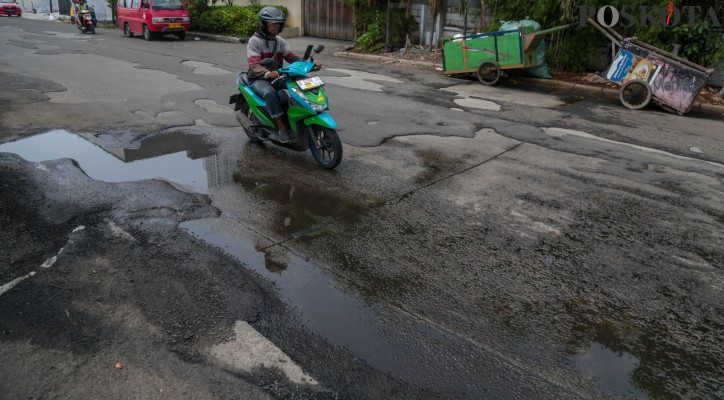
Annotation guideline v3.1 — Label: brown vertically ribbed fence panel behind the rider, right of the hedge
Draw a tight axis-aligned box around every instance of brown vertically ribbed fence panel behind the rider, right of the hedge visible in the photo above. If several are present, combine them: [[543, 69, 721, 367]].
[[304, 0, 354, 40]]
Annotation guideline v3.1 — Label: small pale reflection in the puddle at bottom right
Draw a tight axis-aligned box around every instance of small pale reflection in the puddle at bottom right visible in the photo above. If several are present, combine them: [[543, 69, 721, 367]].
[[574, 342, 648, 399]]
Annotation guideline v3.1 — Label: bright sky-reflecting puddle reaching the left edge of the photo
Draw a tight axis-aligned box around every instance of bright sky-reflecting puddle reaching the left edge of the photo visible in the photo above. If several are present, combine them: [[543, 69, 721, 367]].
[[0, 130, 216, 193]]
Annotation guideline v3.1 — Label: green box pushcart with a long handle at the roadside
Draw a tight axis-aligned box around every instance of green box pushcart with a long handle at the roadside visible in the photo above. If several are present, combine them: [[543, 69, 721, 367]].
[[442, 23, 578, 85]]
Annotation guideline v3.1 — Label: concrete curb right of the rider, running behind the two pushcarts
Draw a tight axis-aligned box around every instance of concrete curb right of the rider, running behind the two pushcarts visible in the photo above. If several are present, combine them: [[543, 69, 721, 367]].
[[334, 51, 724, 116]]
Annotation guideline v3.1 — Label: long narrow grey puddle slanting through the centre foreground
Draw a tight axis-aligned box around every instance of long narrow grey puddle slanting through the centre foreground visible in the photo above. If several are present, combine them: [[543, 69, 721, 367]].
[[180, 219, 404, 370]]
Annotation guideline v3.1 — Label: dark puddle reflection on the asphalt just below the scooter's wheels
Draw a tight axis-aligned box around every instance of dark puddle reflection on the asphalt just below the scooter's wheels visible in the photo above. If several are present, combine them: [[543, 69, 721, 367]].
[[234, 175, 364, 238]]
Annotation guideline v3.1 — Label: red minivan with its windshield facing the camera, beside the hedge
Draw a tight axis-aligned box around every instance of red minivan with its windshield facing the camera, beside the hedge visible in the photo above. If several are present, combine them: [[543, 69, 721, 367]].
[[118, 0, 189, 40]]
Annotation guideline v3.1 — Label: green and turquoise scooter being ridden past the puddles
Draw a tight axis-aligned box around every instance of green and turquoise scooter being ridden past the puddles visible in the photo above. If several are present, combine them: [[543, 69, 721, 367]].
[[229, 45, 342, 169]]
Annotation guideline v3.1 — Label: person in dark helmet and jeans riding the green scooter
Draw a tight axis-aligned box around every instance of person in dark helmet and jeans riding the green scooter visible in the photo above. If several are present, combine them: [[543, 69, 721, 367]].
[[246, 6, 321, 143]]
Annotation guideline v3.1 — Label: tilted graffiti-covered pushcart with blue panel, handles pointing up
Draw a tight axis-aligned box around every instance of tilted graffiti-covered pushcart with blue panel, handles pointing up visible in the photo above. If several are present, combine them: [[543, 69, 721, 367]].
[[588, 19, 714, 115]]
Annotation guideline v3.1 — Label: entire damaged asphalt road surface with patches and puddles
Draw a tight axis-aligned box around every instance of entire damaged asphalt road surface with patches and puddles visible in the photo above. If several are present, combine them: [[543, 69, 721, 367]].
[[0, 19, 724, 399]]
